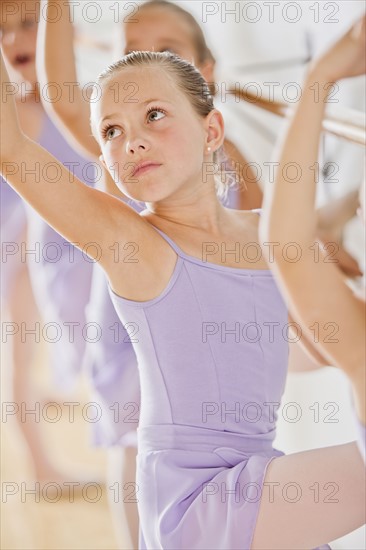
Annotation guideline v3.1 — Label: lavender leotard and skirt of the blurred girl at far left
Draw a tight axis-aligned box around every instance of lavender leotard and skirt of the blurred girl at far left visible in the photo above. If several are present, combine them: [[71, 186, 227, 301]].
[[0, 116, 95, 389]]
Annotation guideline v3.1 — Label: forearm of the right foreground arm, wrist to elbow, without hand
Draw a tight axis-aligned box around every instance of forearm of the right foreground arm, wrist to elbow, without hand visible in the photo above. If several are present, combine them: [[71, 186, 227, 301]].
[[262, 68, 331, 253]]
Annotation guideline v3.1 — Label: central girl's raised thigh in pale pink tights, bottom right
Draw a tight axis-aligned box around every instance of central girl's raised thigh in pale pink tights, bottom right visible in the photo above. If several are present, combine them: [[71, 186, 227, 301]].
[[251, 443, 366, 550]]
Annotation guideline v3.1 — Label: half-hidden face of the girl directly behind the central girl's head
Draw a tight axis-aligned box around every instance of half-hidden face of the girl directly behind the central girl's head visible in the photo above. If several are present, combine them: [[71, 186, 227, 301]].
[[123, 7, 214, 82]]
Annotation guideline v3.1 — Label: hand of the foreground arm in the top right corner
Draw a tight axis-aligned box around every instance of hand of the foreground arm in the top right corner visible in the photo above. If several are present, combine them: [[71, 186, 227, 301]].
[[310, 16, 366, 82]]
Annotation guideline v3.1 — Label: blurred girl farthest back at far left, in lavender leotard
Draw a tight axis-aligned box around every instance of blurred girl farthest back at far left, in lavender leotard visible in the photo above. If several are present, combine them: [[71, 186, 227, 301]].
[[0, 0, 93, 482]]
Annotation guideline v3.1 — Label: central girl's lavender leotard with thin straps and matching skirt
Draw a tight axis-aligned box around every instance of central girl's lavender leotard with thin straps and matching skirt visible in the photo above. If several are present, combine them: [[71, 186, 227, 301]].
[[110, 225, 328, 549]]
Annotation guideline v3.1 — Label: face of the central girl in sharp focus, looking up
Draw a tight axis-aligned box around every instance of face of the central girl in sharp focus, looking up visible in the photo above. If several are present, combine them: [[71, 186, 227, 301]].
[[91, 66, 220, 203]]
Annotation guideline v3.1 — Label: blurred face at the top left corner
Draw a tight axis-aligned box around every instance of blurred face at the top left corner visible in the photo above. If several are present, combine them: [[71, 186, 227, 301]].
[[0, 0, 39, 85]]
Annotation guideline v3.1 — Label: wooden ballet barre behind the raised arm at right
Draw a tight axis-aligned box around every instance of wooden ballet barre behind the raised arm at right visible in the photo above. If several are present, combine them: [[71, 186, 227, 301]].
[[228, 88, 366, 146]]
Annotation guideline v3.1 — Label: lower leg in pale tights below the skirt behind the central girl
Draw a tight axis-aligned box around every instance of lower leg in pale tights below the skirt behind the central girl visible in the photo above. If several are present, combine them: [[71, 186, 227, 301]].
[[107, 447, 139, 550]]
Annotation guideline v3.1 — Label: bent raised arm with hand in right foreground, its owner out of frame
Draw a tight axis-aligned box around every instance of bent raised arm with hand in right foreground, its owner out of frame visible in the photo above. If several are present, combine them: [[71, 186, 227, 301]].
[[261, 18, 365, 376]]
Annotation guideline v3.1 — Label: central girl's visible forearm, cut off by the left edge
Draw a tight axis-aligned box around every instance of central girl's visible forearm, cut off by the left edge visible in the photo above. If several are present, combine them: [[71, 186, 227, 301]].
[[0, 48, 24, 162]]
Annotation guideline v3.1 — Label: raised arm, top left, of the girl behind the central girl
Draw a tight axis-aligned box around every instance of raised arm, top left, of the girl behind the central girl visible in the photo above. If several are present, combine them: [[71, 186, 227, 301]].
[[37, 0, 100, 158]]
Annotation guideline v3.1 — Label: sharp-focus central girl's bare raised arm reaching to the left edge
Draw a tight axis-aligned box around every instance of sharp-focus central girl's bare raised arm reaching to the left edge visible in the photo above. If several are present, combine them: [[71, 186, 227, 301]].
[[0, 50, 146, 274]]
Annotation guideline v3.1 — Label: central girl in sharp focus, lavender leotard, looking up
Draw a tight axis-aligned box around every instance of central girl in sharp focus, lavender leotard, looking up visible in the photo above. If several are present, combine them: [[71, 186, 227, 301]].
[[1, 17, 365, 549]]
